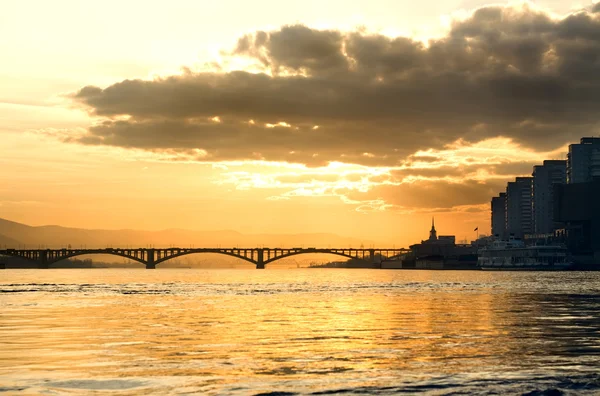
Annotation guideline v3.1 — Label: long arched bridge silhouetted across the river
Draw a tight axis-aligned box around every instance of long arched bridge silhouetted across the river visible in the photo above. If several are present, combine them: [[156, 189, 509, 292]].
[[0, 247, 409, 269]]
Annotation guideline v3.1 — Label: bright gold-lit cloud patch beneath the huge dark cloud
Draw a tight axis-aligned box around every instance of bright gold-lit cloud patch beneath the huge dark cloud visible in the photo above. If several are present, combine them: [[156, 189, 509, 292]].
[[215, 146, 534, 213]]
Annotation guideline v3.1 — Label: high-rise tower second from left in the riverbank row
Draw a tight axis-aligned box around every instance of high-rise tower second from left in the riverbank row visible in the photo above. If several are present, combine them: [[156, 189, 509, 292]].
[[505, 177, 533, 238]]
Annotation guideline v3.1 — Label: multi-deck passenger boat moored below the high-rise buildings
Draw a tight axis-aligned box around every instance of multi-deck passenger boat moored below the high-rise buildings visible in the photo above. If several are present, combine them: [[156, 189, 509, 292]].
[[477, 239, 573, 271]]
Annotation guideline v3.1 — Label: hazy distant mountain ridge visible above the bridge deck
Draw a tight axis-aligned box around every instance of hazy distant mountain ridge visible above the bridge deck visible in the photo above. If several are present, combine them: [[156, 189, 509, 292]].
[[0, 219, 374, 248]]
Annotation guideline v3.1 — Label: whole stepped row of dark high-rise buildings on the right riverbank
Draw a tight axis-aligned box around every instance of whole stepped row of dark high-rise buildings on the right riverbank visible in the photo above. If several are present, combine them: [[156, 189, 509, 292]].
[[491, 137, 600, 263]]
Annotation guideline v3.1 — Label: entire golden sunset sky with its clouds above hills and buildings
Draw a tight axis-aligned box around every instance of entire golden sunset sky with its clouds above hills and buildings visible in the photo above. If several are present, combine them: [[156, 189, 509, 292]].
[[0, 0, 600, 246]]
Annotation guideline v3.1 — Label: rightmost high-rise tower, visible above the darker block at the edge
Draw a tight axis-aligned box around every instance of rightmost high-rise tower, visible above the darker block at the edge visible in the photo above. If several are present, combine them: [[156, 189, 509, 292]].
[[567, 137, 600, 184]]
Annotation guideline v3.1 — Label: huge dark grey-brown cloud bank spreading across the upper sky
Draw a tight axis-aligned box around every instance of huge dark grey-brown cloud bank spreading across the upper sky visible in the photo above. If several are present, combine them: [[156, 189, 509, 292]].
[[74, 5, 600, 165]]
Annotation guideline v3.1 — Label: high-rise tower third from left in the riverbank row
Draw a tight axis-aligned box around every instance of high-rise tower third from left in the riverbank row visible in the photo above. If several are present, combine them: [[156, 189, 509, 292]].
[[531, 160, 567, 234]]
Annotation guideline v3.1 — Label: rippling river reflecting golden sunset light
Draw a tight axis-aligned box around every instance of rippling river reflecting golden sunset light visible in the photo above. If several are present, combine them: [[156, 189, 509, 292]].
[[0, 269, 600, 395]]
